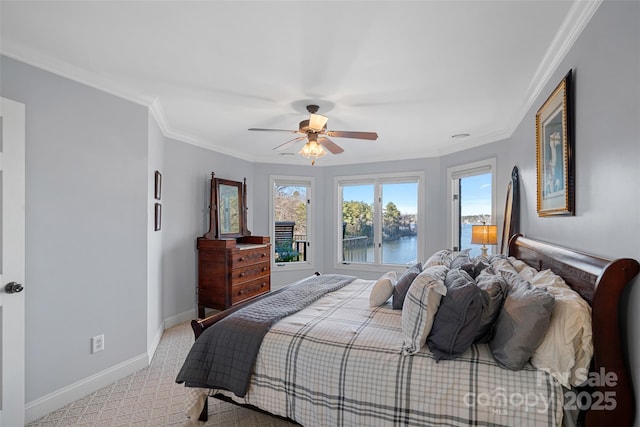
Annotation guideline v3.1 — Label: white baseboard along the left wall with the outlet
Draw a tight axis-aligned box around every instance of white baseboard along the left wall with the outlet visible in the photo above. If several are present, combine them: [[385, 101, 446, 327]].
[[25, 354, 149, 423]]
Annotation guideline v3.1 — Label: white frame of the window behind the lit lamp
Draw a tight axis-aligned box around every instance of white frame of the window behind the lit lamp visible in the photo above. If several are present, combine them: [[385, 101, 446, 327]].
[[447, 157, 501, 254]]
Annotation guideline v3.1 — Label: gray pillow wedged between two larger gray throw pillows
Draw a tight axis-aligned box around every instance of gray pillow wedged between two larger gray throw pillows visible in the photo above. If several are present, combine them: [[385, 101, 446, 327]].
[[473, 267, 507, 342]]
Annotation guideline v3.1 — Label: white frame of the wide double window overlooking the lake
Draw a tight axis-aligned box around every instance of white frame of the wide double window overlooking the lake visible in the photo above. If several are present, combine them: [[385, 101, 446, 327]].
[[332, 171, 427, 272]]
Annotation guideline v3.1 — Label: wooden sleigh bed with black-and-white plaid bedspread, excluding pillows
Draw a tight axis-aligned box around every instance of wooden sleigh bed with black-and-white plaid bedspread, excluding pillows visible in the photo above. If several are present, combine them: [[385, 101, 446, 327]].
[[177, 235, 640, 426]]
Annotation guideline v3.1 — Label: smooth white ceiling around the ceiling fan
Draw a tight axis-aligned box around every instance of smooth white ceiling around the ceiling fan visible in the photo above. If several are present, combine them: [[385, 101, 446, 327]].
[[0, 0, 599, 165]]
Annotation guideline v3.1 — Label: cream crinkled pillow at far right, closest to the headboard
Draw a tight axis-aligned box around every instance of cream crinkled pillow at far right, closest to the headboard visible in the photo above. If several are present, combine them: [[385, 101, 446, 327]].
[[531, 270, 593, 388]]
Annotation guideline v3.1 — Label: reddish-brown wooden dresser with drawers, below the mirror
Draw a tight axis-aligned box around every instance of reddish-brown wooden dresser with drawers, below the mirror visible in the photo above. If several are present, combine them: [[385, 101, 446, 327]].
[[197, 236, 271, 318]]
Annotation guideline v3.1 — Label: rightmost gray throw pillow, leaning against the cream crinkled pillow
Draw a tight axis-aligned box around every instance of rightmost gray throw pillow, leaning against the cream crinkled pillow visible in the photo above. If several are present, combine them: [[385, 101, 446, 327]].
[[489, 272, 555, 371]]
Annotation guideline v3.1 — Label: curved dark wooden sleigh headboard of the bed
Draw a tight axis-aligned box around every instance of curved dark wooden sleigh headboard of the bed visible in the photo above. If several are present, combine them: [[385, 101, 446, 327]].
[[509, 234, 640, 427]]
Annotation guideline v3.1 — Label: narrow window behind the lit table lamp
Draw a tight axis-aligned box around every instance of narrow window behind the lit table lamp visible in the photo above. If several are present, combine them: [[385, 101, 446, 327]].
[[447, 159, 496, 256]]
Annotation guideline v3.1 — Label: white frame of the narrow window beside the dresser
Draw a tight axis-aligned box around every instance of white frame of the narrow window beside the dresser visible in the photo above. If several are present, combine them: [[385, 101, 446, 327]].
[[269, 175, 317, 272]]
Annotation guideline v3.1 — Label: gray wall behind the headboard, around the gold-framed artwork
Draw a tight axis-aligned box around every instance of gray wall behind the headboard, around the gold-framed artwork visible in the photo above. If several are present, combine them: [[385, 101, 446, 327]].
[[511, 1, 640, 414]]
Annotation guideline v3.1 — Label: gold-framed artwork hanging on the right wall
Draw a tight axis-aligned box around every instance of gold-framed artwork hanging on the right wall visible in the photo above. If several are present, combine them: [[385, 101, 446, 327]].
[[536, 70, 575, 216]]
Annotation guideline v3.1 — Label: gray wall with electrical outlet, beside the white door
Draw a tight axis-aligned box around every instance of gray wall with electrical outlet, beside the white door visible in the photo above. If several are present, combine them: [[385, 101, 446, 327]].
[[0, 57, 148, 402]]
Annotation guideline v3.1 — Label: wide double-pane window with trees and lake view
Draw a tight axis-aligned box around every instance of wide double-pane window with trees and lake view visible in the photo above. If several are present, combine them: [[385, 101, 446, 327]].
[[336, 173, 424, 266]]
